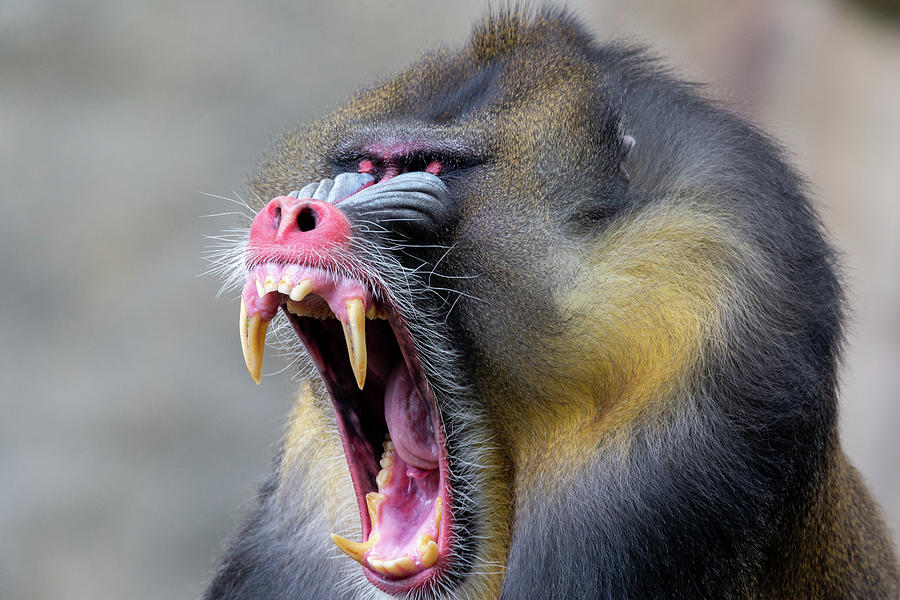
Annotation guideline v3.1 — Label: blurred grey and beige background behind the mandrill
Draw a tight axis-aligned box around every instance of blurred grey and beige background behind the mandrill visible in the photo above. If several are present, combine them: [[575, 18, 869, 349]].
[[0, 0, 900, 600]]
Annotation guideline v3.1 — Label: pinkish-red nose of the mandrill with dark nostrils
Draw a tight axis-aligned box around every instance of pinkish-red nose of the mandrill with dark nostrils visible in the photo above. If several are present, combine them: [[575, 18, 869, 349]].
[[250, 196, 350, 255]]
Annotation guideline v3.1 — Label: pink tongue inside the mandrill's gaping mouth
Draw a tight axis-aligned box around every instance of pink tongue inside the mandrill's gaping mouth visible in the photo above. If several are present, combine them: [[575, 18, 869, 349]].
[[384, 360, 438, 469]]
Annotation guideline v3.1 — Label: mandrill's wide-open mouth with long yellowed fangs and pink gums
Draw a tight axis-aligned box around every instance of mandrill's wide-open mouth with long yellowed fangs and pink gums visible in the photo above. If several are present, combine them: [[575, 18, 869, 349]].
[[240, 262, 452, 593]]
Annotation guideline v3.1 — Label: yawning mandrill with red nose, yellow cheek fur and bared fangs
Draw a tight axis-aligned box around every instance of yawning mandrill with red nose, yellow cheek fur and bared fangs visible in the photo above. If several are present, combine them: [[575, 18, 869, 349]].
[[205, 9, 898, 600]]
